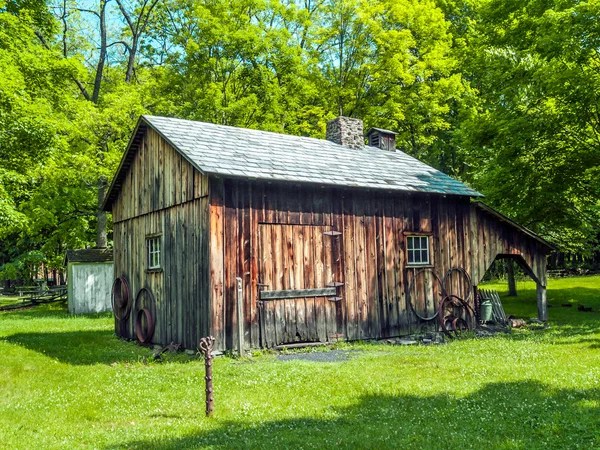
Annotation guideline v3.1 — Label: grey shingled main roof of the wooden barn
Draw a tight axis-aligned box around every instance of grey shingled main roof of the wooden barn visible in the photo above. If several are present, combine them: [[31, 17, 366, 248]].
[[105, 115, 483, 209]]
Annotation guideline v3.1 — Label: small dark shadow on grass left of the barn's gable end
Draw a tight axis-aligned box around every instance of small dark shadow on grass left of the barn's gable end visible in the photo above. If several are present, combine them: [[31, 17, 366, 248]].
[[4, 330, 150, 365]]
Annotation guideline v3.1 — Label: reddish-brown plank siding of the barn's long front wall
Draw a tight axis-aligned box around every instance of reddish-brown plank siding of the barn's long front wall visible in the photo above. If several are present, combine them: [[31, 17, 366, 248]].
[[210, 179, 545, 349]]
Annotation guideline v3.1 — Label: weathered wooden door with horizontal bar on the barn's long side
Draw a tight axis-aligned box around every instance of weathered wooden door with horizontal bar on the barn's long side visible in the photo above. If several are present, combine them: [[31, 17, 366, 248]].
[[258, 224, 341, 347]]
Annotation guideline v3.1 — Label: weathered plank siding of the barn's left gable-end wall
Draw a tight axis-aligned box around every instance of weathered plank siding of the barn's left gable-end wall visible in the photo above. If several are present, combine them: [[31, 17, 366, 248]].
[[113, 129, 209, 348]]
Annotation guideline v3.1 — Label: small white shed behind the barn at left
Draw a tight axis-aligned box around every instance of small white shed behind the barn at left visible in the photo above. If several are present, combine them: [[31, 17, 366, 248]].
[[65, 248, 114, 314]]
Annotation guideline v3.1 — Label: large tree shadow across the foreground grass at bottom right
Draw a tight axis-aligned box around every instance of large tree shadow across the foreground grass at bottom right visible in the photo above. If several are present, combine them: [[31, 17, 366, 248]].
[[107, 382, 600, 450]]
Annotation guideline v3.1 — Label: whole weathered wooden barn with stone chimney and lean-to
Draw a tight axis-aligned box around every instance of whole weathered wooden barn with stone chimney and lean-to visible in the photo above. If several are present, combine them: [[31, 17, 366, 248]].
[[105, 116, 551, 350]]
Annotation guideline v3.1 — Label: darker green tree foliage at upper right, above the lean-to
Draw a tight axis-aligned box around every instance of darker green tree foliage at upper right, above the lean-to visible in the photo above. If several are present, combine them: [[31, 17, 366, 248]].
[[460, 1, 600, 252]]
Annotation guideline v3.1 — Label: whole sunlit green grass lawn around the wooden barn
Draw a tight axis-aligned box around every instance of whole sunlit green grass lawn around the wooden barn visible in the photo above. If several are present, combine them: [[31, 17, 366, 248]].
[[0, 277, 600, 450]]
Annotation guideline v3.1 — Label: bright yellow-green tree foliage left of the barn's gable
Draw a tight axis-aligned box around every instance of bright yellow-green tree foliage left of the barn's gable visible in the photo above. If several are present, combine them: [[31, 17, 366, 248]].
[[0, 3, 144, 274]]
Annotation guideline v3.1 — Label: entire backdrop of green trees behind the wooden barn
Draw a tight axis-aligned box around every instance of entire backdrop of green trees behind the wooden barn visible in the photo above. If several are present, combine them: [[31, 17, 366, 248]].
[[0, 0, 600, 274]]
